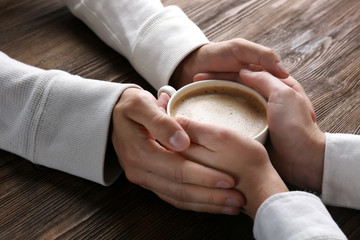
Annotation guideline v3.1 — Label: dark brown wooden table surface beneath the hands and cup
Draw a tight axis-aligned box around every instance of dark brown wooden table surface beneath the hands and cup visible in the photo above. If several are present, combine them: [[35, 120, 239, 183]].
[[0, 0, 360, 239]]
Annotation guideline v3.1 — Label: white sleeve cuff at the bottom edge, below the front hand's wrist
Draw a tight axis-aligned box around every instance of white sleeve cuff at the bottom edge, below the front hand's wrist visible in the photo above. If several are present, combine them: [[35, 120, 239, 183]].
[[254, 191, 347, 240]]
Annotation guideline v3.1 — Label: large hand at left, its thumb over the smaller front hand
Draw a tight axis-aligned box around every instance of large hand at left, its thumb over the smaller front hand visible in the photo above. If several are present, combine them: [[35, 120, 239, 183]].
[[112, 88, 244, 214]]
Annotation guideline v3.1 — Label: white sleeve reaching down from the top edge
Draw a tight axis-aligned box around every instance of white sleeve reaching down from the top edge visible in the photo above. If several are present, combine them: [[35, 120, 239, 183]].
[[65, 0, 208, 89]]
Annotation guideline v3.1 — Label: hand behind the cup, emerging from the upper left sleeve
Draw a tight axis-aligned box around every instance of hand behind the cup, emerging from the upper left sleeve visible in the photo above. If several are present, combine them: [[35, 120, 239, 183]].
[[169, 38, 289, 88]]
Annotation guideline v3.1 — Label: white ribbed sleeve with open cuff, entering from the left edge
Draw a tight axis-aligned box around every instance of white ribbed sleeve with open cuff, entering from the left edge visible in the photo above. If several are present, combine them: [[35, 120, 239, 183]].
[[0, 52, 137, 185]]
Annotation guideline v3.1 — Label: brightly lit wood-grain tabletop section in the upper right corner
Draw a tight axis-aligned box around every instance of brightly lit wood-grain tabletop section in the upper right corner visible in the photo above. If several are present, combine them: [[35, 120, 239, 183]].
[[164, 0, 360, 134]]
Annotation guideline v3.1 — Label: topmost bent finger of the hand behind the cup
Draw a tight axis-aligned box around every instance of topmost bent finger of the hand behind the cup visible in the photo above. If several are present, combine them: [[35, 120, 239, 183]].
[[231, 39, 289, 78]]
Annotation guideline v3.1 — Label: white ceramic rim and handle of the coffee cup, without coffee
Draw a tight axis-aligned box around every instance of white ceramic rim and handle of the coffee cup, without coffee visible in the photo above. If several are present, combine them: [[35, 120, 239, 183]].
[[158, 80, 268, 144]]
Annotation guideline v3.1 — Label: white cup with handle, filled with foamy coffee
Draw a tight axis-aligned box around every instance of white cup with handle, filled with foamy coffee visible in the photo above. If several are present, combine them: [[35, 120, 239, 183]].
[[159, 80, 268, 143]]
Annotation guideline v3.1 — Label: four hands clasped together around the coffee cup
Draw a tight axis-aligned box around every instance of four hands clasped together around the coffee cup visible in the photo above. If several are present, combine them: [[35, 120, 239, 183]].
[[112, 39, 325, 219]]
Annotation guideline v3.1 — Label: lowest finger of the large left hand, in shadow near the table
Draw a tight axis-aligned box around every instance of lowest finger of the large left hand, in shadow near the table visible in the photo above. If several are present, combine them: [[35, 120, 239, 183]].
[[157, 193, 242, 215]]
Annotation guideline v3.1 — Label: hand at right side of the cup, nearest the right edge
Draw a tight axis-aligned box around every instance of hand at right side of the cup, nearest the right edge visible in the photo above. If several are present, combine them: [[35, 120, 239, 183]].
[[240, 70, 326, 192]]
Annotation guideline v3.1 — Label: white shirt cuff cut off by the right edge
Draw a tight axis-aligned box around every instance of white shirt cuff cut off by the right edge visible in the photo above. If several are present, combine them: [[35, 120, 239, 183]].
[[321, 133, 360, 209]]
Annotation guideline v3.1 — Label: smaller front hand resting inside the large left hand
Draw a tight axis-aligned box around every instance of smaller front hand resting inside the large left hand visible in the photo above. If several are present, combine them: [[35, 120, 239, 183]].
[[178, 118, 288, 219]]
